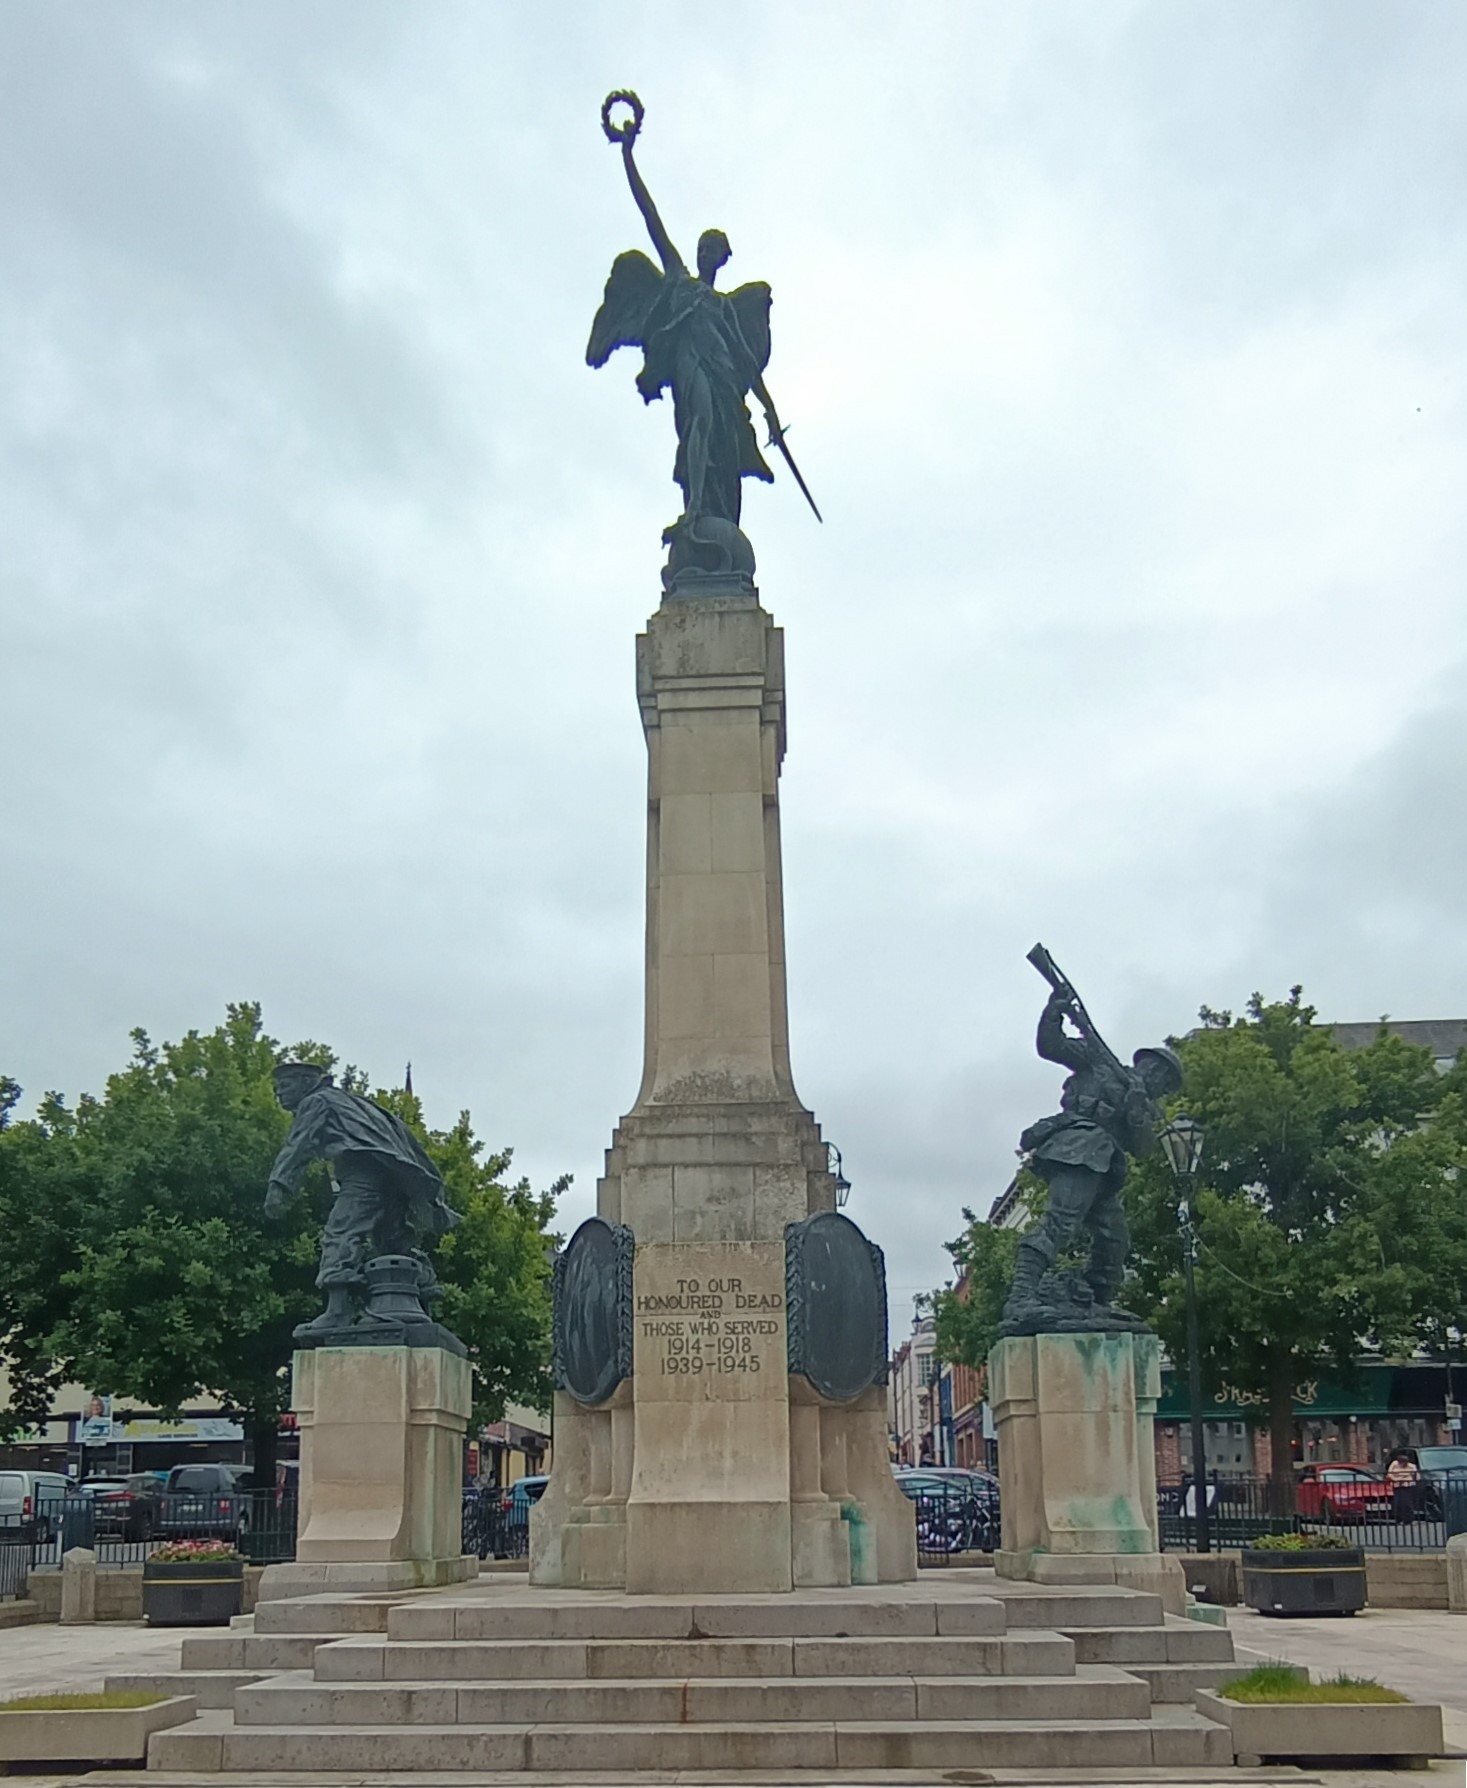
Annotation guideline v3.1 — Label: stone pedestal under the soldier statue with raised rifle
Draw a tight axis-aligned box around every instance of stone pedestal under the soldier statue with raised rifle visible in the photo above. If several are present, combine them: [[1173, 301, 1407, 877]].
[[988, 1334, 1186, 1615]]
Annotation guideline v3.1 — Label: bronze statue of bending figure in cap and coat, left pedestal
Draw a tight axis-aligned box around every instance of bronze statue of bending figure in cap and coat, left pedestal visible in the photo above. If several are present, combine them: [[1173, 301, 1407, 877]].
[[265, 1062, 463, 1345]]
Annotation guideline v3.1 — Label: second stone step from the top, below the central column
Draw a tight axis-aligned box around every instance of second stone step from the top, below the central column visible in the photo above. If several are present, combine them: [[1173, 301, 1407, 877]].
[[315, 1631, 1080, 1683]]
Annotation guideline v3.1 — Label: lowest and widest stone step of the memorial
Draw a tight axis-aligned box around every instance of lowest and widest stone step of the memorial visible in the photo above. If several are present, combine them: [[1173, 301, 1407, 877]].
[[148, 1709, 1233, 1781]]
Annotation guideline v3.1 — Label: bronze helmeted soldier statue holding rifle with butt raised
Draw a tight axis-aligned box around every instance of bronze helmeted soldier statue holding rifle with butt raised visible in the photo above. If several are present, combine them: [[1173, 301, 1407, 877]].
[[1002, 944, 1183, 1336]]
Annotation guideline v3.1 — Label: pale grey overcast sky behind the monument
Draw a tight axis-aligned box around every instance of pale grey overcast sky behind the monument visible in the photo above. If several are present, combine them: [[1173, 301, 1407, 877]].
[[0, 0, 1467, 1337]]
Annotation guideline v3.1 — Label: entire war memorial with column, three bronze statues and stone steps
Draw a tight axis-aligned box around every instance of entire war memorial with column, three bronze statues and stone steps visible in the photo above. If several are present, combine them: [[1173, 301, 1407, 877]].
[[103, 93, 1338, 1781]]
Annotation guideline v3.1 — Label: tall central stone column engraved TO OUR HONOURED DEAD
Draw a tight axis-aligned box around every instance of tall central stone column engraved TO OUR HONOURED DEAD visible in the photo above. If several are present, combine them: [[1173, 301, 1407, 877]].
[[530, 594, 916, 1593]]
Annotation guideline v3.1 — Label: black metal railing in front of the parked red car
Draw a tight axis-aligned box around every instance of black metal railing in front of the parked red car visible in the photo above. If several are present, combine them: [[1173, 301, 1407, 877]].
[[1157, 1472, 1467, 1552]]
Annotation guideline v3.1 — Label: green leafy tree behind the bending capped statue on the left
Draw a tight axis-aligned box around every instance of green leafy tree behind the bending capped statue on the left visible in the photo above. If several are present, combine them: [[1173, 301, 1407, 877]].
[[0, 1005, 558, 1475]]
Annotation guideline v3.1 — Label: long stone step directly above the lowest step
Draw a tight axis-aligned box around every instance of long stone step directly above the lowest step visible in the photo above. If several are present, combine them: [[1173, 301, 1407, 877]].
[[234, 1666, 1150, 1727]]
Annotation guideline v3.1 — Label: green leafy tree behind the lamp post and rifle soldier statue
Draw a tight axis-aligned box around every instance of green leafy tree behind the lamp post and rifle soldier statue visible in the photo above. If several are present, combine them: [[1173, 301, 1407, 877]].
[[1125, 987, 1467, 1507]]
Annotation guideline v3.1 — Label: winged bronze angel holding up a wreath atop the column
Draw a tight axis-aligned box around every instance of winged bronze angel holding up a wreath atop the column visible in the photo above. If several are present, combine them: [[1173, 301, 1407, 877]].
[[585, 93, 819, 590]]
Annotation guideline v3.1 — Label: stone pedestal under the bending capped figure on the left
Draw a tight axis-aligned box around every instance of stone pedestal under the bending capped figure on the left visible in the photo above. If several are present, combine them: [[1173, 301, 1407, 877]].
[[259, 1346, 478, 1600]]
